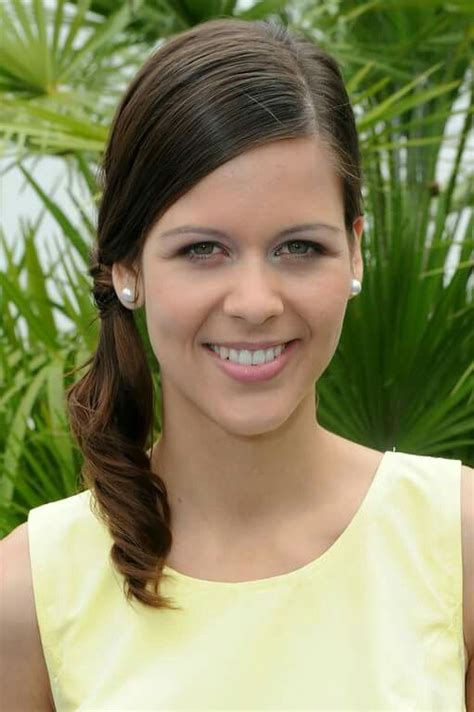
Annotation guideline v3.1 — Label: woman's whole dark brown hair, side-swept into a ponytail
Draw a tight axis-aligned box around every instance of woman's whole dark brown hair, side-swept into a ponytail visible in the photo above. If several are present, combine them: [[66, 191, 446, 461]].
[[67, 18, 362, 608]]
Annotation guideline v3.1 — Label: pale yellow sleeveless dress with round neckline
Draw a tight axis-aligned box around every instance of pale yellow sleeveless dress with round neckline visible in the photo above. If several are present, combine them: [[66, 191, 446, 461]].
[[28, 451, 466, 712]]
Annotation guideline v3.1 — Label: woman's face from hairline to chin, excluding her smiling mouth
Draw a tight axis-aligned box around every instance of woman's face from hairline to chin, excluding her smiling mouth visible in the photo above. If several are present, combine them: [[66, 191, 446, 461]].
[[118, 138, 362, 435]]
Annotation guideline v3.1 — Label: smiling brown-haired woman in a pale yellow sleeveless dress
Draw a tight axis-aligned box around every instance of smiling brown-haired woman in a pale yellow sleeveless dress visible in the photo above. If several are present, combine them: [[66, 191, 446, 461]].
[[2, 19, 474, 712]]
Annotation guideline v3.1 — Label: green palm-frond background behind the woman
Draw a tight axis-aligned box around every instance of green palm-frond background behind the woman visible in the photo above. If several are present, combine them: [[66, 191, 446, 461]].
[[0, 0, 474, 537]]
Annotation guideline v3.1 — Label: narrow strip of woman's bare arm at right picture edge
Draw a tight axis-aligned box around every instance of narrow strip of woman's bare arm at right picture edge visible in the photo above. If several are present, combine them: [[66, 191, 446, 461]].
[[461, 465, 474, 661]]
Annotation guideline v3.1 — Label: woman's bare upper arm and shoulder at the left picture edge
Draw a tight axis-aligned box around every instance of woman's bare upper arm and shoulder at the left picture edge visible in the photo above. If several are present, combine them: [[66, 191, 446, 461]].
[[0, 522, 54, 712]]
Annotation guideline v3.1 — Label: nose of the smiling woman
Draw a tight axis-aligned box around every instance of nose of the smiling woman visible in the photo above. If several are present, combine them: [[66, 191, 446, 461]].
[[224, 259, 284, 324]]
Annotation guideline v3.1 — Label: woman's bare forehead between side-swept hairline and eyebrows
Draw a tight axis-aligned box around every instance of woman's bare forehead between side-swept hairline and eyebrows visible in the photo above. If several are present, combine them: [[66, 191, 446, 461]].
[[150, 137, 343, 238]]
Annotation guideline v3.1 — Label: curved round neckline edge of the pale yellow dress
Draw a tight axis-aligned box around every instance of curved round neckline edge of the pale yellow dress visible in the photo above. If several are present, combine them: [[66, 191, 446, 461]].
[[163, 450, 396, 591]]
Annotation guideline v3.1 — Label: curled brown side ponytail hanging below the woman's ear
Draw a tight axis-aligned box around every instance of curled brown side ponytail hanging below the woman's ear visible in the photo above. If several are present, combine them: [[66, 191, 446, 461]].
[[67, 250, 179, 609]]
